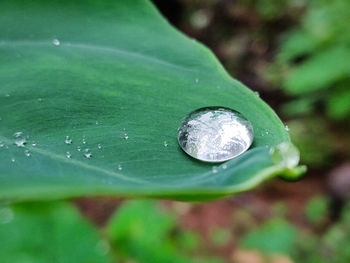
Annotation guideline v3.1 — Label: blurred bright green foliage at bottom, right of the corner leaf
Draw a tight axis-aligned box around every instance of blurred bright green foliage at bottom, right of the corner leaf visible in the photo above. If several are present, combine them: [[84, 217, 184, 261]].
[[107, 200, 221, 263]]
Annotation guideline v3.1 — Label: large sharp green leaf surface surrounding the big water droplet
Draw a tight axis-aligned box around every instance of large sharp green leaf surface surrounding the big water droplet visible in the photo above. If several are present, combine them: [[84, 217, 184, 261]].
[[0, 0, 300, 200]]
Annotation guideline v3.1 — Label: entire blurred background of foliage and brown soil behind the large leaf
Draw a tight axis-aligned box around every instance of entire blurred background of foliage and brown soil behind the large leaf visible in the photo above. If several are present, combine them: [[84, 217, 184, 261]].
[[0, 0, 350, 263]]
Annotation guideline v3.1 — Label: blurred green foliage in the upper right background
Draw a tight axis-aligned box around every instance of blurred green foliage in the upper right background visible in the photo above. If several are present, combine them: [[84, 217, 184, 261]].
[[272, 0, 350, 120]]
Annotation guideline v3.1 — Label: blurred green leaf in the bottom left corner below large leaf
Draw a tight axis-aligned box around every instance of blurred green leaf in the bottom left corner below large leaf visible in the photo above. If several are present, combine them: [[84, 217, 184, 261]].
[[0, 202, 111, 263]]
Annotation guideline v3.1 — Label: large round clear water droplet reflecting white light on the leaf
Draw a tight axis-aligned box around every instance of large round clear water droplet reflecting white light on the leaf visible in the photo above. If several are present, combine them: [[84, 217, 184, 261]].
[[178, 107, 253, 162]]
